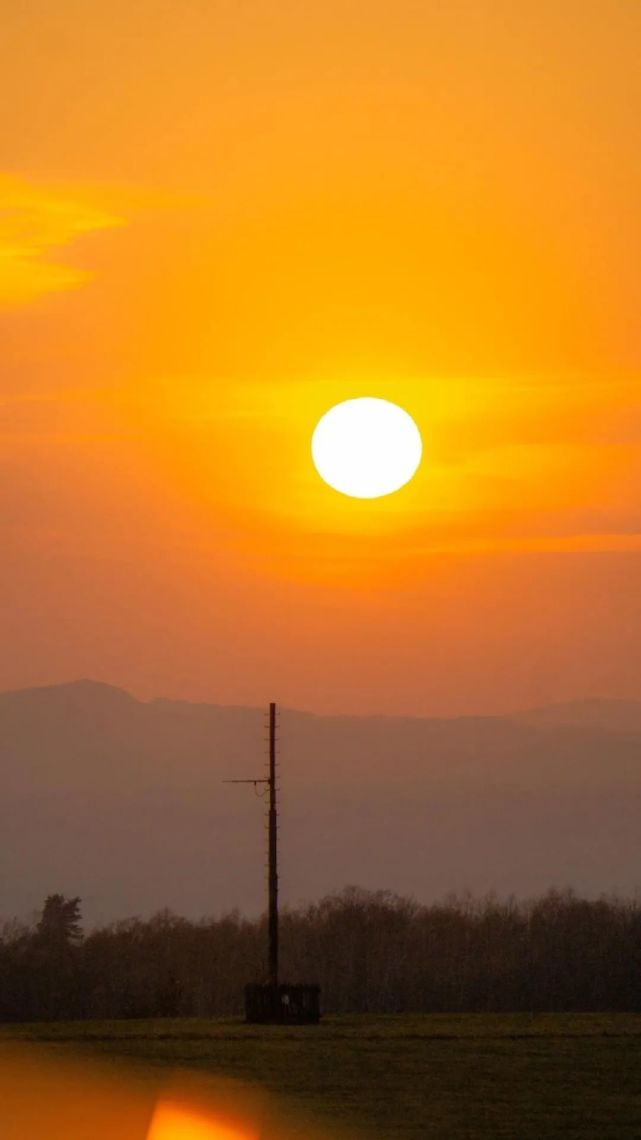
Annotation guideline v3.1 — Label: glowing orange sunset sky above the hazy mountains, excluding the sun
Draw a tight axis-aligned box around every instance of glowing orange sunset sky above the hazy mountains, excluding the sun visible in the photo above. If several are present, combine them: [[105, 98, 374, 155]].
[[0, 0, 641, 715]]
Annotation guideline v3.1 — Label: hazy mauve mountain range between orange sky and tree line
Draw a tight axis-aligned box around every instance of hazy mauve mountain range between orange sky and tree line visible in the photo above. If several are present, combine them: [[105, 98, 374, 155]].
[[0, 681, 641, 923]]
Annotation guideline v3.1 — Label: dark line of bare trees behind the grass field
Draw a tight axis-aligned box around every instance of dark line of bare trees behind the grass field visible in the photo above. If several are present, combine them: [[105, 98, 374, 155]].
[[0, 887, 641, 1021]]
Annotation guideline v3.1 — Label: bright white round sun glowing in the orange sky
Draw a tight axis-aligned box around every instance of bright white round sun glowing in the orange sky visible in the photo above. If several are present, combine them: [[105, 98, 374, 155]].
[[311, 396, 423, 498]]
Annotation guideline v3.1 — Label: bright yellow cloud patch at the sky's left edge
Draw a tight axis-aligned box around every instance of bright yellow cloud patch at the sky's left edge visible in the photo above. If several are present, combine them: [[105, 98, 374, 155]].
[[0, 174, 124, 308]]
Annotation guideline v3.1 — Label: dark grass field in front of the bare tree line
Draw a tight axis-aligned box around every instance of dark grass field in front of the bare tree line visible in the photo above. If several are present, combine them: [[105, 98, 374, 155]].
[[0, 1013, 641, 1140]]
